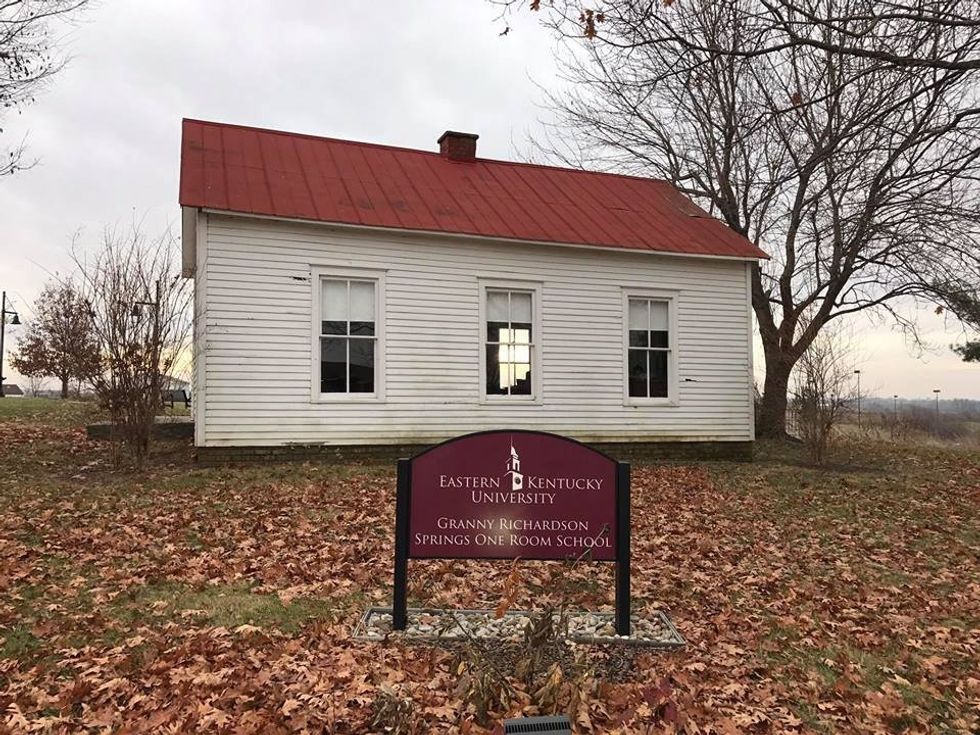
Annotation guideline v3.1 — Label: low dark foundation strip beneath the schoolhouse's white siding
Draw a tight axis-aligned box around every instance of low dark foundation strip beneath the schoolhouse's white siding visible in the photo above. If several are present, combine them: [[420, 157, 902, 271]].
[[197, 441, 753, 465]]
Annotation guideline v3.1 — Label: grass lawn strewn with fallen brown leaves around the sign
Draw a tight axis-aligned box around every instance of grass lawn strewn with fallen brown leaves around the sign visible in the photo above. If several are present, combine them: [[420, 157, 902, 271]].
[[0, 400, 980, 733]]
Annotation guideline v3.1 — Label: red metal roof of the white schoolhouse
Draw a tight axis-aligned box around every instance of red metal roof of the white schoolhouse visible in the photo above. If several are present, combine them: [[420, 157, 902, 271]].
[[180, 120, 767, 258]]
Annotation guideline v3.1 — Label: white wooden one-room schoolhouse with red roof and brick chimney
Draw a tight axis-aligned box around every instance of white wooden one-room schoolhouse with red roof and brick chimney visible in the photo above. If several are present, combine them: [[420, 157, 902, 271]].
[[180, 120, 766, 458]]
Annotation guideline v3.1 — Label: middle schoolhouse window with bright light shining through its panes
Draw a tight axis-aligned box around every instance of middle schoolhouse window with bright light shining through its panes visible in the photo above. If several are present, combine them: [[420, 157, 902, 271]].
[[484, 288, 536, 398]]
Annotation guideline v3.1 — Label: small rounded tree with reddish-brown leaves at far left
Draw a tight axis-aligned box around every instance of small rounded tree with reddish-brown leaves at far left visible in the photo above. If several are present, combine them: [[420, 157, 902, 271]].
[[10, 281, 98, 398]]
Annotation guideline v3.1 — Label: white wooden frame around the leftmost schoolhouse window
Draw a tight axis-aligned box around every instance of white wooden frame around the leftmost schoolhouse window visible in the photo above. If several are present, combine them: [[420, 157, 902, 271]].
[[310, 265, 387, 403]]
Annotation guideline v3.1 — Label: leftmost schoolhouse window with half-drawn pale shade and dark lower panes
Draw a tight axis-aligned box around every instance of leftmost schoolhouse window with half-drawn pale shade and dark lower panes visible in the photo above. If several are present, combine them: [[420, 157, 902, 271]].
[[320, 277, 379, 396]]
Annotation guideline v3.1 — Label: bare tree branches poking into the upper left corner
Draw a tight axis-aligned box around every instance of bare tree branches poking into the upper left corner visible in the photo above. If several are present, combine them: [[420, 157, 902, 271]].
[[0, 0, 88, 176]]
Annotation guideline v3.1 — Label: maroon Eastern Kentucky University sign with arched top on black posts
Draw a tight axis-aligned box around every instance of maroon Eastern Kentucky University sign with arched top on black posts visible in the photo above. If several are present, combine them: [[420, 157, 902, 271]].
[[392, 430, 629, 635]]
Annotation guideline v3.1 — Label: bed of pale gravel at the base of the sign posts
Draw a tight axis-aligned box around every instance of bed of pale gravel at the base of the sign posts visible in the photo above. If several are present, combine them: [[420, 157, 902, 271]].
[[354, 607, 684, 648]]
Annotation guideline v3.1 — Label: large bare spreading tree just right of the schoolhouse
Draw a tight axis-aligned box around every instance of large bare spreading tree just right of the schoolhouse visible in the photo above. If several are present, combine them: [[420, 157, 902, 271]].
[[524, 0, 980, 436]]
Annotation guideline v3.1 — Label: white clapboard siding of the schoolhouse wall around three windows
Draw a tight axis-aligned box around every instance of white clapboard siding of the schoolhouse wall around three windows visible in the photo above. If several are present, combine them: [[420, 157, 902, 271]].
[[195, 213, 752, 446]]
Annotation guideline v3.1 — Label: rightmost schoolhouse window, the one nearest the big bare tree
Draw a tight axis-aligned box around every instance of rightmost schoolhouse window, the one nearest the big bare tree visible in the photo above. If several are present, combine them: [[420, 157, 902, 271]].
[[627, 296, 673, 398]]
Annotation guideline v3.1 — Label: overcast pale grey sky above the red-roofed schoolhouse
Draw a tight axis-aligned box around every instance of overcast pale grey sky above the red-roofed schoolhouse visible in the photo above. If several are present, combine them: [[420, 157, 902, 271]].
[[0, 0, 980, 399]]
